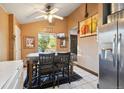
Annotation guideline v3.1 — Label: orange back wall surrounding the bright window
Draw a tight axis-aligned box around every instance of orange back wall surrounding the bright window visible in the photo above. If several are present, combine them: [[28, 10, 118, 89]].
[[21, 19, 68, 59]]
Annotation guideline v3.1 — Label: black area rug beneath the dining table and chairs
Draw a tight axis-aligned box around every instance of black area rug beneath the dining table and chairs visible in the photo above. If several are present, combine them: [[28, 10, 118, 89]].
[[24, 72, 82, 89]]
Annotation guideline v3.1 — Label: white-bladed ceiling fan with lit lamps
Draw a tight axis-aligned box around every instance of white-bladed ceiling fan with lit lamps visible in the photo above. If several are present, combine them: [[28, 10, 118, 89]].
[[35, 4, 63, 23]]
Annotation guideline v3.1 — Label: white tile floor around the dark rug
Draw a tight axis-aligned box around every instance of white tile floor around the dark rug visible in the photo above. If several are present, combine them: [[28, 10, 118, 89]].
[[24, 66, 98, 89]]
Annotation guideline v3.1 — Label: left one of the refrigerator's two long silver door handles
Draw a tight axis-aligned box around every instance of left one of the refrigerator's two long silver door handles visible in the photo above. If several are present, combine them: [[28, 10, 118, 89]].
[[112, 34, 117, 67]]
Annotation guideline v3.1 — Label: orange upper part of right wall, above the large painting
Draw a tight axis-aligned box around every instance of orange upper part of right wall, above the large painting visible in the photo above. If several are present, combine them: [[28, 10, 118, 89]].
[[67, 3, 98, 30]]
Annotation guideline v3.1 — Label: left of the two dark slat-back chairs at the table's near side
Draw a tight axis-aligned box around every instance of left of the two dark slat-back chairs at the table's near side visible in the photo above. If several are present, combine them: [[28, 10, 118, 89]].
[[38, 53, 55, 88]]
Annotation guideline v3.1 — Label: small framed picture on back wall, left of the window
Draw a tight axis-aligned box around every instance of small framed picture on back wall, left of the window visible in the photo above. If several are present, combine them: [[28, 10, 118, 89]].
[[24, 36, 35, 48]]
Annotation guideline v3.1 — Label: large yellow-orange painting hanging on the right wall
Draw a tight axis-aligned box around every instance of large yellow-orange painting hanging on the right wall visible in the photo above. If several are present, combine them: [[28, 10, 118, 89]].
[[79, 14, 98, 37]]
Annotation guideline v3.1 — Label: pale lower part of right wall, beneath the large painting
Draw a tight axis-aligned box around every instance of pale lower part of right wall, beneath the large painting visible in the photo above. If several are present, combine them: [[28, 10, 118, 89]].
[[78, 36, 99, 73]]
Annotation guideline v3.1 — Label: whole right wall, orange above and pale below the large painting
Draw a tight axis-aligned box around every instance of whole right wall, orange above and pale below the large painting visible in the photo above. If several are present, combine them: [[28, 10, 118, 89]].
[[67, 4, 98, 73]]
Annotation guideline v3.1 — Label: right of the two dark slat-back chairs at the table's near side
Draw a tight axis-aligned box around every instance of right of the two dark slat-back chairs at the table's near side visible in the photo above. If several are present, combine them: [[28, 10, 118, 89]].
[[56, 52, 70, 85]]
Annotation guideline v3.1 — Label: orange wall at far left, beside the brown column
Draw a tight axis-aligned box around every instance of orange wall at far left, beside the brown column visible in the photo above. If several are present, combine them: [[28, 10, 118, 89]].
[[0, 6, 21, 61]]
